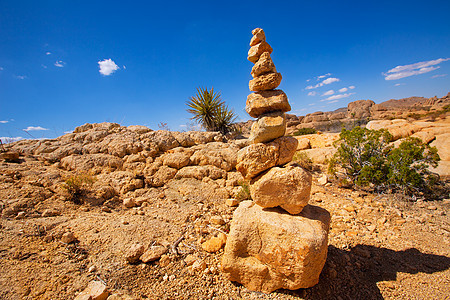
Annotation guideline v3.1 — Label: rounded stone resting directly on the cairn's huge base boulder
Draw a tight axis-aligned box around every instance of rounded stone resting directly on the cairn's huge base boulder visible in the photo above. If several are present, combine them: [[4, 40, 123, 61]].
[[250, 165, 312, 215]]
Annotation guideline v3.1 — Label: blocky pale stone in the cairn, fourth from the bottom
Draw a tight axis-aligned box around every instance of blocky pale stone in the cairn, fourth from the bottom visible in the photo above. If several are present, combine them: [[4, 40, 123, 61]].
[[249, 111, 286, 144]]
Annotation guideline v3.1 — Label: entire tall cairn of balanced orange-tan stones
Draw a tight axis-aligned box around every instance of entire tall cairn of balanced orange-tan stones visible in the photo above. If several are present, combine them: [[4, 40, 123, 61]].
[[221, 28, 330, 293]]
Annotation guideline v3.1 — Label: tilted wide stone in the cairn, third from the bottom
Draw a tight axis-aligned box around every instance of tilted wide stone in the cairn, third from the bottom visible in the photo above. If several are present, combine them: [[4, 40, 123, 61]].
[[236, 136, 297, 179]]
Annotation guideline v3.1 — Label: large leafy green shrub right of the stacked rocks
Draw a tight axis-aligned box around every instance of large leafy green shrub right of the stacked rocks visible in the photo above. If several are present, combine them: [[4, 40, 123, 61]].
[[329, 127, 439, 194]]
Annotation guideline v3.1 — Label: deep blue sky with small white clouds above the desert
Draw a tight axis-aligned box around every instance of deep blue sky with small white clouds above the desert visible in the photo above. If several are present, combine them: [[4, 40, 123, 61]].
[[0, 0, 450, 140]]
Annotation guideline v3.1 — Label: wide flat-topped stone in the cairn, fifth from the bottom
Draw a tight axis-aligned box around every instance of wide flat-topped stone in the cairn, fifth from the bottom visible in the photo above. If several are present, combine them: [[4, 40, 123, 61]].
[[245, 90, 291, 118]]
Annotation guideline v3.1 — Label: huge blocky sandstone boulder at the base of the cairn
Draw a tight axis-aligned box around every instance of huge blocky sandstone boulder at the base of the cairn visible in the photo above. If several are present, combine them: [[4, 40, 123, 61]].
[[221, 201, 330, 293]]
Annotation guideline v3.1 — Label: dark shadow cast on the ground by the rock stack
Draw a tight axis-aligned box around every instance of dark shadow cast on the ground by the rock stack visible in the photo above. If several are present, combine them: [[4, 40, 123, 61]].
[[278, 245, 450, 299]]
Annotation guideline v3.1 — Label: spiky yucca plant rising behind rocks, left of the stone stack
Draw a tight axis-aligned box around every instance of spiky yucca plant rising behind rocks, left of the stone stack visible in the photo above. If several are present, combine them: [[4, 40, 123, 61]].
[[186, 88, 236, 134]]
